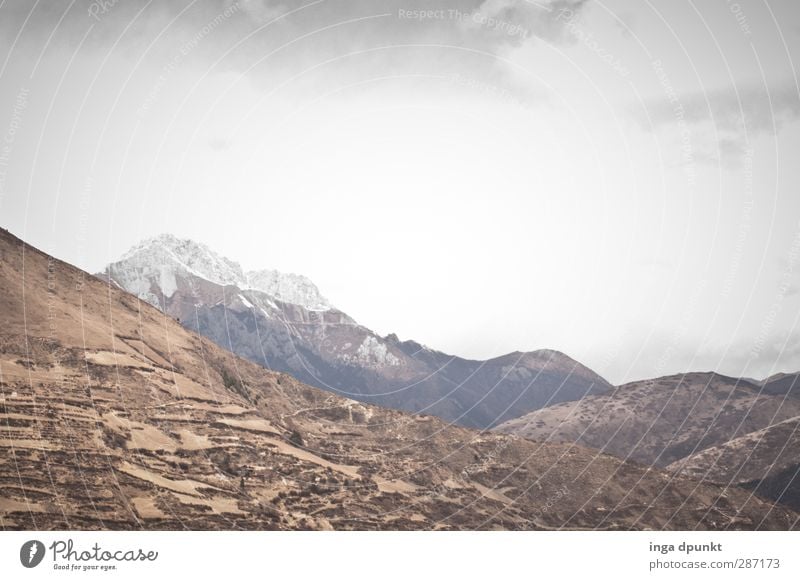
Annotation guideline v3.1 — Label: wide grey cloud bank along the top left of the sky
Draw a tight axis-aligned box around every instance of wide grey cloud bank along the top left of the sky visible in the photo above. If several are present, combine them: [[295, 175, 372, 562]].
[[0, 0, 588, 112]]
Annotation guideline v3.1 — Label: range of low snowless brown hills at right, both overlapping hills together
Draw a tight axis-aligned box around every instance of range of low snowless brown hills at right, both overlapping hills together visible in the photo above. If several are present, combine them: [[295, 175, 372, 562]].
[[496, 373, 800, 509]]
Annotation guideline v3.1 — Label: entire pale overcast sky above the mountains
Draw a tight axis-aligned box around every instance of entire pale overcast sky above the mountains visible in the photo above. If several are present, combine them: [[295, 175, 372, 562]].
[[0, 0, 800, 383]]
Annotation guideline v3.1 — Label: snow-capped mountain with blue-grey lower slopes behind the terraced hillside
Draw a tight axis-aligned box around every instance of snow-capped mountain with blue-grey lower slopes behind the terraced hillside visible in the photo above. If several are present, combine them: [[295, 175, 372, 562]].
[[101, 235, 610, 429]]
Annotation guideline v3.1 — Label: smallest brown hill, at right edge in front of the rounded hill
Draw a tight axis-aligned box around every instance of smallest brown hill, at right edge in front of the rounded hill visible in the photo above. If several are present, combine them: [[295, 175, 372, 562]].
[[667, 416, 800, 510]]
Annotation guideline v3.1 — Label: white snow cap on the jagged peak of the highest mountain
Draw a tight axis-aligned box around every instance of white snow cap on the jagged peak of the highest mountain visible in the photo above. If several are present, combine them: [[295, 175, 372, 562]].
[[106, 234, 331, 311]]
